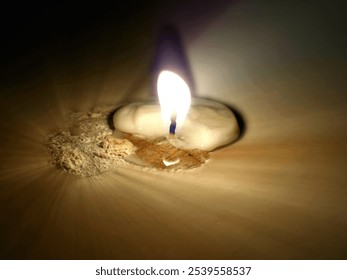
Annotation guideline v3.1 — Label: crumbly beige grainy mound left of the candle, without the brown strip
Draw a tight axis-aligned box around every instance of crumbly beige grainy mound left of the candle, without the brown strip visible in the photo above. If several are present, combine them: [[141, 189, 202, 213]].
[[47, 107, 134, 177]]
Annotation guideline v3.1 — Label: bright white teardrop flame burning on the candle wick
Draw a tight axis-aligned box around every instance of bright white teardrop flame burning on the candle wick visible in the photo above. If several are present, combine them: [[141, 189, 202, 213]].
[[157, 70, 191, 129]]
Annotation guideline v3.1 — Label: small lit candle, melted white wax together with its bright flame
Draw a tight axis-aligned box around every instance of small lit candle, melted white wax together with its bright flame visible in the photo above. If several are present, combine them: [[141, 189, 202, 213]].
[[113, 71, 239, 151]]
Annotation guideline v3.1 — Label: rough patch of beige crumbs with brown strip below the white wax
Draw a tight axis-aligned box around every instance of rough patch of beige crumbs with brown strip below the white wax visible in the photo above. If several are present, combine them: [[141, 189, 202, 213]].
[[46, 106, 209, 177]]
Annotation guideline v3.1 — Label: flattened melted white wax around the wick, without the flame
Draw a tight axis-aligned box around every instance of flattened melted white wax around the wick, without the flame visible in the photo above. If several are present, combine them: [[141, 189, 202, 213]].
[[113, 99, 239, 151]]
